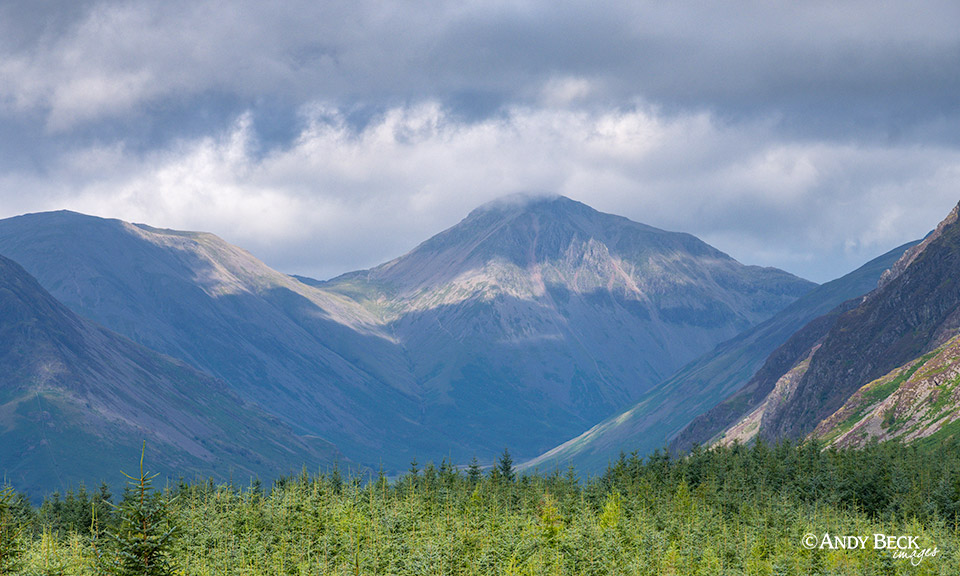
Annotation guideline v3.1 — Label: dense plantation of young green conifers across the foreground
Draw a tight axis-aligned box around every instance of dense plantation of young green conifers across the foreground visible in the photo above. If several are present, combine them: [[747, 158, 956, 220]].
[[0, 440, 960, 576]]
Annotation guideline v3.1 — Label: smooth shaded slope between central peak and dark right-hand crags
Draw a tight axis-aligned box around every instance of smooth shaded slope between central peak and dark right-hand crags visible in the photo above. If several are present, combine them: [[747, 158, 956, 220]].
[[524, 243, 916, 471]]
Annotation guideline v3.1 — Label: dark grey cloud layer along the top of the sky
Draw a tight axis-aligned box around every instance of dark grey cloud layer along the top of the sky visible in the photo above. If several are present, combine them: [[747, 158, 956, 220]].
[[0, 0, 960, 142]]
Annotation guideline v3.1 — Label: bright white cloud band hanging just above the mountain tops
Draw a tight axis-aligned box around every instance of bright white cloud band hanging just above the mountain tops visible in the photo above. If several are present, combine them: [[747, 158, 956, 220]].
[[7, 101, 960, 281]]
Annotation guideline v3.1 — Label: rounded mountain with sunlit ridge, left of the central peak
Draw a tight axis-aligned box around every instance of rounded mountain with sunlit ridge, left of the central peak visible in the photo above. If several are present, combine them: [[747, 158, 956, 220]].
[[0, 211, 442, 465]]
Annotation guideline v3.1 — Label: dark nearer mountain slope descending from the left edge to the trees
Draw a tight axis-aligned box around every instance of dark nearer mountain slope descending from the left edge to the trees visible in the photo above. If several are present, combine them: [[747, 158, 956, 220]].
[[0, 257, 336, 495]]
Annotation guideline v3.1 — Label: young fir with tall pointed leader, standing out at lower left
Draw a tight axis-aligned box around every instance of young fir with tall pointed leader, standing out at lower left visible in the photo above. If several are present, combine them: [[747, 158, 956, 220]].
[[100, 446, 177, 576]]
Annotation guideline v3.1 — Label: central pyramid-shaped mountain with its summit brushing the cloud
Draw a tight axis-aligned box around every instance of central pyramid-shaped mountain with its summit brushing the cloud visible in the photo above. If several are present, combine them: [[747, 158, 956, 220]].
[[321, 197, 813, 454]]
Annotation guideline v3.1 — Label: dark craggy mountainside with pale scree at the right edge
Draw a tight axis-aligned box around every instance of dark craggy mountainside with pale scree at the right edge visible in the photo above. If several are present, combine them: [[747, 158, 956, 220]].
[[690, 202, 960, 450]]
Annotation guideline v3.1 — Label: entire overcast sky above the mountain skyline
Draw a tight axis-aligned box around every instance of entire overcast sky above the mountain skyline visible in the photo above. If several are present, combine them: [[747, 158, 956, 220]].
[[0, 0, 960, 282]]
